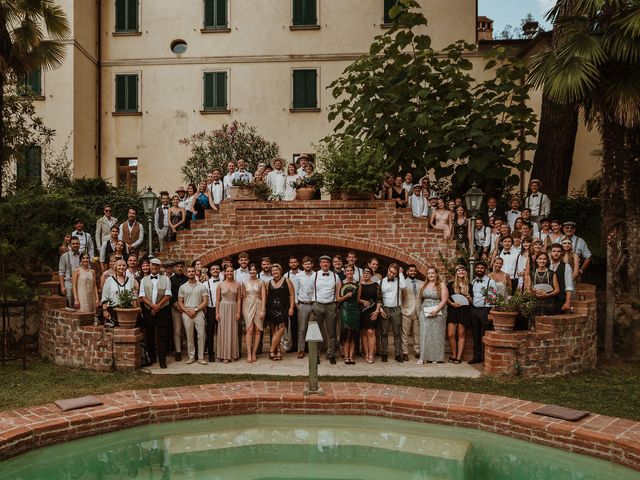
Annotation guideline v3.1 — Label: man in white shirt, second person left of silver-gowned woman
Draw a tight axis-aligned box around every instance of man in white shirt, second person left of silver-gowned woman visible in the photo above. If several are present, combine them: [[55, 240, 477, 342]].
[[380, 263, 405, 363]]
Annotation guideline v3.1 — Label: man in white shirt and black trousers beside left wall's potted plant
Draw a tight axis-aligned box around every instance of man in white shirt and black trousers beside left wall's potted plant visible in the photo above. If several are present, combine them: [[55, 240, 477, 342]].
[[140, 258, 171, 368]]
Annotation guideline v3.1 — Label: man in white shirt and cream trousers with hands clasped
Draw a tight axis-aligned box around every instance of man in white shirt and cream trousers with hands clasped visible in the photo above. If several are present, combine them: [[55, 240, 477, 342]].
[[178, 267, 209, 365]]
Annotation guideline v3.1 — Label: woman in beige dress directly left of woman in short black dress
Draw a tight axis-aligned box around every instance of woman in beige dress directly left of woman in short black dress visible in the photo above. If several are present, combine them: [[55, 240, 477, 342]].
[[242, 263, 265, 363]]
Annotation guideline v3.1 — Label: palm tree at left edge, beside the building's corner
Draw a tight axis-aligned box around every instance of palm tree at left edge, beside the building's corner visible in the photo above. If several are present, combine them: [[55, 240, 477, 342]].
[[0, 0, 69, 196]]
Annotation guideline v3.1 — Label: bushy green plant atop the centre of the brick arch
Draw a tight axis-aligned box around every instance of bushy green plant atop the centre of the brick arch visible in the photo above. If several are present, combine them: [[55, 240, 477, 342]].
[[317, 136, 388, 199]]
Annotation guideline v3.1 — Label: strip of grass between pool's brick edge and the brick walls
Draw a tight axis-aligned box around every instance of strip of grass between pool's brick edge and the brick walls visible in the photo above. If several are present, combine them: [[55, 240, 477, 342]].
[[0, 360, 640, 421]]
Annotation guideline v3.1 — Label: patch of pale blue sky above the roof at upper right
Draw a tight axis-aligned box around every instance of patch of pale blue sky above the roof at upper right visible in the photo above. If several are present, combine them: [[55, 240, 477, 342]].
[[478, 0, 555, 37]]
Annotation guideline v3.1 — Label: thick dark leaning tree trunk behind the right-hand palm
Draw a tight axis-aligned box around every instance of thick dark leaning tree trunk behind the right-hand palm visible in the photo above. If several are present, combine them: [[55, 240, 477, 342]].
[[531, 94, 579, 197]]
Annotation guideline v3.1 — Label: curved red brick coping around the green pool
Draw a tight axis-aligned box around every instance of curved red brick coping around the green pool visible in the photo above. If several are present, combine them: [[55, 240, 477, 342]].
[[0, 381, 640, 471]]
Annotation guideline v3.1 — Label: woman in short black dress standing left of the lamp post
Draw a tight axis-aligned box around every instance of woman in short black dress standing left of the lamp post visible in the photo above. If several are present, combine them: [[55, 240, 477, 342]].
[[264, 263, 295, 360]]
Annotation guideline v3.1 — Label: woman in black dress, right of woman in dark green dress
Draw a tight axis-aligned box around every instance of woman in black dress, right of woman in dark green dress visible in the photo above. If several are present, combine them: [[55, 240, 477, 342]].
[[358, 267, 382, 363]]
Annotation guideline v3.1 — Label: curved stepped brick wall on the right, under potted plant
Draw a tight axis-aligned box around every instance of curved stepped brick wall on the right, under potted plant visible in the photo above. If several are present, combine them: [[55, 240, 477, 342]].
[[483, 284, 597, 377]]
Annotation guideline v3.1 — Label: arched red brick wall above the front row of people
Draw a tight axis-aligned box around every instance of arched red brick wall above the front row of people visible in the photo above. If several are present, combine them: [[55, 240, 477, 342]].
[[166, 200, 454, 274]]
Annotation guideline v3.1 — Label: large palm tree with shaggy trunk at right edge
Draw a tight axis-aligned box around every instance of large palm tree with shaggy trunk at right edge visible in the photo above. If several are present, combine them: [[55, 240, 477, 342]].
[[529, 0, 640, 354]]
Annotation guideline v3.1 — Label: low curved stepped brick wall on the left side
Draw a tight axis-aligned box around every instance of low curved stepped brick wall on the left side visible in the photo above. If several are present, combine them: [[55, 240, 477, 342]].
[[38, 297, 142, 371]]
